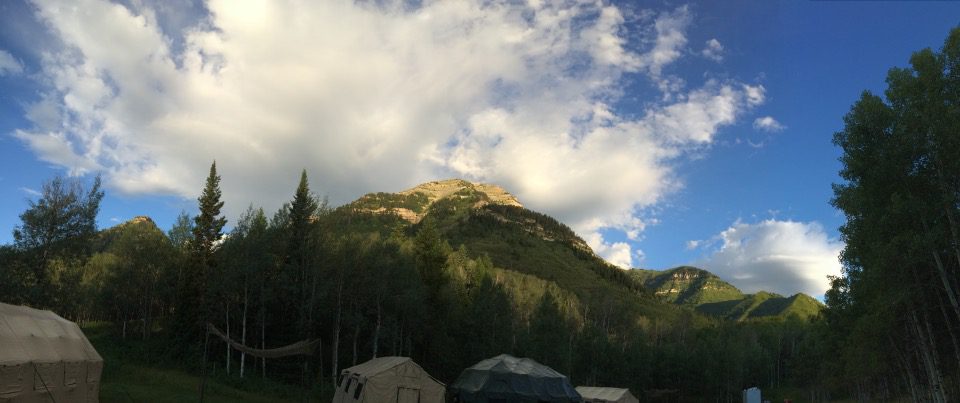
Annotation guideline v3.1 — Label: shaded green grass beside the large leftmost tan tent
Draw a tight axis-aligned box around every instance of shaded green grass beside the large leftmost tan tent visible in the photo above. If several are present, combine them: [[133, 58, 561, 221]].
[[83, 323, 320, 403]]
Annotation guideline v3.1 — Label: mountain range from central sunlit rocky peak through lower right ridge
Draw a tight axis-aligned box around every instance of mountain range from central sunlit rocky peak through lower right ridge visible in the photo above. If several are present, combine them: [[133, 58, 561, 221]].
[[335, 179, 822, 320]]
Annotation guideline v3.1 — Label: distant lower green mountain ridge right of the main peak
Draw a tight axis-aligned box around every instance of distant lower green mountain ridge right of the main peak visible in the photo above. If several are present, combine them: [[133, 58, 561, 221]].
[[630, 266, 823, 320]]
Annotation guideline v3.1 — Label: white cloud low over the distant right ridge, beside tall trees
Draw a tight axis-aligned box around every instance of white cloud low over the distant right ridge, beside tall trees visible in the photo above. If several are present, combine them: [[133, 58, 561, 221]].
[[696, 220, 843, 297]]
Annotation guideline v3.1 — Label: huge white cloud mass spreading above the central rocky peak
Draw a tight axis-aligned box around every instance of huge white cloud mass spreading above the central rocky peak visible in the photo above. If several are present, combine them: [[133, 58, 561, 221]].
[[16, 0, 765, 272]]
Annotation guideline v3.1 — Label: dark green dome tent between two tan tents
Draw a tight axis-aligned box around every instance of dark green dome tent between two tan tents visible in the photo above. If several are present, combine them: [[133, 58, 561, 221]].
[[447, 354, 583, 403]]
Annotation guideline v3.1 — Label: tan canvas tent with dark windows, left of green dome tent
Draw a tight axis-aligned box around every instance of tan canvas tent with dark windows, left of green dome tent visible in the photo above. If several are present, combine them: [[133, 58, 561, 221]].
[[333, 357, 446, 403]]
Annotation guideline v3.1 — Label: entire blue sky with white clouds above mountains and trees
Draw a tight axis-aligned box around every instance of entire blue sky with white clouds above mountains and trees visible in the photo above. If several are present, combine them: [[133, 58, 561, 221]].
[[0, 0, 960, 298]]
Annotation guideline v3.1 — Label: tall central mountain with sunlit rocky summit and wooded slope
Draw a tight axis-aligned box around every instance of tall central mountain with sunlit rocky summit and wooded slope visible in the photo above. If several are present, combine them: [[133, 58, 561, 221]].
[[332, 179, 681, 322]]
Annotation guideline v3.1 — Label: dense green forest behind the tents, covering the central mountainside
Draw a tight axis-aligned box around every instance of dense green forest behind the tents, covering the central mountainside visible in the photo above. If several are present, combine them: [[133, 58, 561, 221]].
[[0, 30, 960, 402]]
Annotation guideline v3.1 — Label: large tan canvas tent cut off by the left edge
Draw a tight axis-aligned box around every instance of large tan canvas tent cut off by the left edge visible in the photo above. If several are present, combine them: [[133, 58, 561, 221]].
[[0, 303, 103, 403]]
